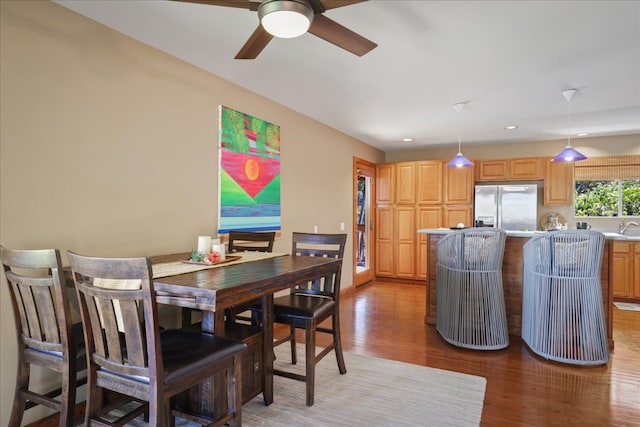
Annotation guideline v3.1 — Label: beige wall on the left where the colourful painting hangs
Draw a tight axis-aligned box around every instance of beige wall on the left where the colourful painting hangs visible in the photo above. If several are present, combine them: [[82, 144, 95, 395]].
[[0, 1, 384, 425]]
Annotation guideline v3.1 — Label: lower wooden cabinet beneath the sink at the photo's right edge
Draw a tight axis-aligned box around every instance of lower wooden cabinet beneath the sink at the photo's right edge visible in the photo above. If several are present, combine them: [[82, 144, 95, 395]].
[[612, 241, 640, 302]]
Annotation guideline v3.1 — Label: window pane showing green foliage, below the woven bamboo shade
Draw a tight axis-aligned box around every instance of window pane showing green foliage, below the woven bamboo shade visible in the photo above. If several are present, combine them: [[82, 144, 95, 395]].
[[574, 179, 640, 217]]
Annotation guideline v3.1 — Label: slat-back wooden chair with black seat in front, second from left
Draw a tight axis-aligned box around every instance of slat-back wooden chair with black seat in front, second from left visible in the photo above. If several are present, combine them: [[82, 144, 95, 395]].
[[68, 252, 246, 427]]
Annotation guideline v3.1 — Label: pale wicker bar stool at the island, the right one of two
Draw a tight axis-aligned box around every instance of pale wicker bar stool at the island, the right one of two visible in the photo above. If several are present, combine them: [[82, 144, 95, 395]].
[[522, 230, 609, 365]]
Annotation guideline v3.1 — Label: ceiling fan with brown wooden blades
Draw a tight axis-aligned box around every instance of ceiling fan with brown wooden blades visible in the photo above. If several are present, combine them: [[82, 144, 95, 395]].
[[173, 0, 377, 59]]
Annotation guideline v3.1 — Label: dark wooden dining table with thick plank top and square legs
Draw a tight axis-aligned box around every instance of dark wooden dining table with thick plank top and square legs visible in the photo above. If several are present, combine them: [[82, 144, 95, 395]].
[[150, 253, 342, 416]]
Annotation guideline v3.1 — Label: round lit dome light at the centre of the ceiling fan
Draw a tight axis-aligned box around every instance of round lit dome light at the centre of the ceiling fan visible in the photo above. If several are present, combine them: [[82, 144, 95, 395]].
[[258, 0, 314, 39]]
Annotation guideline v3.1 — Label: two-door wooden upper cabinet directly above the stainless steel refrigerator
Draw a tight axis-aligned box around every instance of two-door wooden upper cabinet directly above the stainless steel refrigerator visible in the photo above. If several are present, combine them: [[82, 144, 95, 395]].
[[476, 157, 544, 182]]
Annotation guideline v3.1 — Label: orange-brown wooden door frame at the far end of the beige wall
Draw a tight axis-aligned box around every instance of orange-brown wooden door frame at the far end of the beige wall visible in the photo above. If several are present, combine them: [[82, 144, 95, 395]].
[[352, 157, 376, 288]]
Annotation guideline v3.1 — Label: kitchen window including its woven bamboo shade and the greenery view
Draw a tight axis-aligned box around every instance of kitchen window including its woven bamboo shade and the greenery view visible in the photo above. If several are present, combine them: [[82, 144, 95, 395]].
[[574, 154, 640, 218]]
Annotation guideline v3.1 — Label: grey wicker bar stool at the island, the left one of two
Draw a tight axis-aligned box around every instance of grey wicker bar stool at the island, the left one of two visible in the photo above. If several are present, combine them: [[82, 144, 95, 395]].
[[436, 228, 509, 350]]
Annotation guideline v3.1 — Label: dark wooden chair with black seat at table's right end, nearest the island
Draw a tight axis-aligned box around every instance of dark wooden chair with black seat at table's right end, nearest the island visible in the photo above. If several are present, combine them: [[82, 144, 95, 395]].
[[260, 232, 347, 406]]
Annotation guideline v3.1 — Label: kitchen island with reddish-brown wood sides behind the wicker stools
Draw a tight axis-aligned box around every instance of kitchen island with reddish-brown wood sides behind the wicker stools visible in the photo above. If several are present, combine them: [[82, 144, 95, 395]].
[[418, 228, 615, 349]]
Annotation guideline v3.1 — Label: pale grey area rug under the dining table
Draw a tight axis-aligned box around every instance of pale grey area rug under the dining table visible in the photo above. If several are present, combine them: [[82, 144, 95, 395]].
[[124, 344, 487, 427]]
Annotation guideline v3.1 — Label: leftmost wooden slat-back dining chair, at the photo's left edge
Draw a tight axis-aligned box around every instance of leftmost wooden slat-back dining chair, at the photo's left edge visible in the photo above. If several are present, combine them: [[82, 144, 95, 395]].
[[0, 247, 87, 426]]
